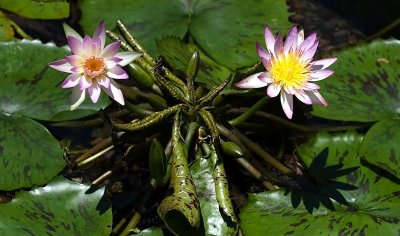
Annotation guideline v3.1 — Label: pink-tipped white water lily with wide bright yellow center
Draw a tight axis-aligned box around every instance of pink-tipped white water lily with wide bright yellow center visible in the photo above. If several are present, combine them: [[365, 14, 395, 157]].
[[235, 26, 336, 119]]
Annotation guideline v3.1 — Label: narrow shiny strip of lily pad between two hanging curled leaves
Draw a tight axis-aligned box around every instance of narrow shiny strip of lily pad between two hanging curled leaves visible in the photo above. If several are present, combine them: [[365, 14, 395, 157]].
[[190, 158, 236, 235]]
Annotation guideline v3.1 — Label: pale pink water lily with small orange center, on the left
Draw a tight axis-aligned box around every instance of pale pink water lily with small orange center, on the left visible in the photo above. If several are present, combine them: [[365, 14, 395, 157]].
[[49, 21, 141, 111]]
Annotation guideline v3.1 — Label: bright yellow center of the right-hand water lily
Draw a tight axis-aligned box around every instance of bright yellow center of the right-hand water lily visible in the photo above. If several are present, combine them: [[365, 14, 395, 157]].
[[269, 53, 310, 89]]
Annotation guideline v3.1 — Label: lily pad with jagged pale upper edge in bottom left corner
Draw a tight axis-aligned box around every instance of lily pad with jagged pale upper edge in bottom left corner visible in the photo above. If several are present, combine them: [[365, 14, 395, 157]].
[[0, 178, 112, 235]]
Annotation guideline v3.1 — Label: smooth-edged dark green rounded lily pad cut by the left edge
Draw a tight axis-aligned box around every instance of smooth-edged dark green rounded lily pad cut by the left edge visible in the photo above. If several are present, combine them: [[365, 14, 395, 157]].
[[0, 112, 67, 190]]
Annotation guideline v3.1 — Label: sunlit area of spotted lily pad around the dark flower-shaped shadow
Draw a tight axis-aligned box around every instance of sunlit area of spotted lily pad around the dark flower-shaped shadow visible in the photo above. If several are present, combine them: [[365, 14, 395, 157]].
[[239, 131, 400, 235]]
